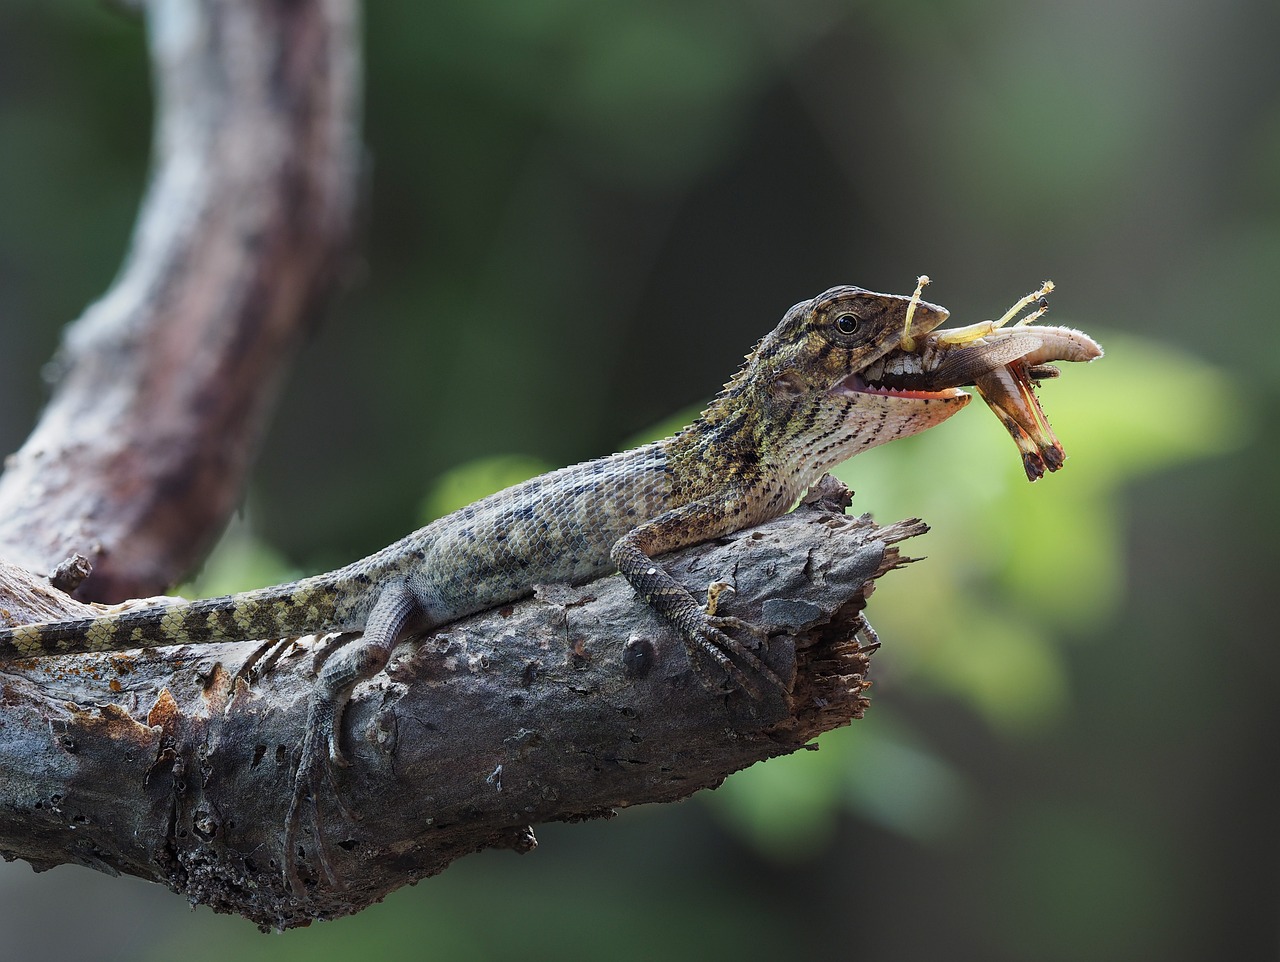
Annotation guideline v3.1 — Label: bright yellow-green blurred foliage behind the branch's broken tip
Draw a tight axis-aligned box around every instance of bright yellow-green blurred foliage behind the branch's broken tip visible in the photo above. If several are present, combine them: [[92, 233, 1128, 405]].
[[855, 329, 1248, 730]]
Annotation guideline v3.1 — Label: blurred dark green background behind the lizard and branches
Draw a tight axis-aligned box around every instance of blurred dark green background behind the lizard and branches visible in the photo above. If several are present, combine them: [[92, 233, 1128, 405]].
[[0, 0, 1280, 962]]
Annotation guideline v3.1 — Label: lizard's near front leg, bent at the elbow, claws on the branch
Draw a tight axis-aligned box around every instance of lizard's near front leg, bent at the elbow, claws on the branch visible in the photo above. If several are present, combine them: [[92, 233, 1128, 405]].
[[609, 496, 790, 698]]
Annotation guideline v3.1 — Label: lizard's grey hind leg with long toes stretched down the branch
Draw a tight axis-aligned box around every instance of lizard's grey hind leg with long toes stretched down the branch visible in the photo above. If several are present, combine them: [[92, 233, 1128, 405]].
[[284, 582, 421, 893]]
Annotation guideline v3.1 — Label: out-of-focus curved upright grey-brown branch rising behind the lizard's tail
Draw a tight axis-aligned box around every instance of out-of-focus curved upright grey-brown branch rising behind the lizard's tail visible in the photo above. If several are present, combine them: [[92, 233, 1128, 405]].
[[0, 0, 360, 601]]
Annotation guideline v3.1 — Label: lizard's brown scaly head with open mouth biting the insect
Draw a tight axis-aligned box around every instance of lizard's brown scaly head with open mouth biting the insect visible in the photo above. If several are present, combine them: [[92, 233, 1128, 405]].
[[704, 287, 969, 485]]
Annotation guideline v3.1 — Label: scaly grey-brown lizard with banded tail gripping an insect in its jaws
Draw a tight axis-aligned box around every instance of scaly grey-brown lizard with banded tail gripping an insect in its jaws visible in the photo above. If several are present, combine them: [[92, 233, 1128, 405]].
[[0, 279, 1095, 890]]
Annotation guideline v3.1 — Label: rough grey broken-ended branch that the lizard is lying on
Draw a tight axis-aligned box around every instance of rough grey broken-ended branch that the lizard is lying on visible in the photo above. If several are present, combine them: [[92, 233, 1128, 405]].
[[0, 488, 924, 927]]
